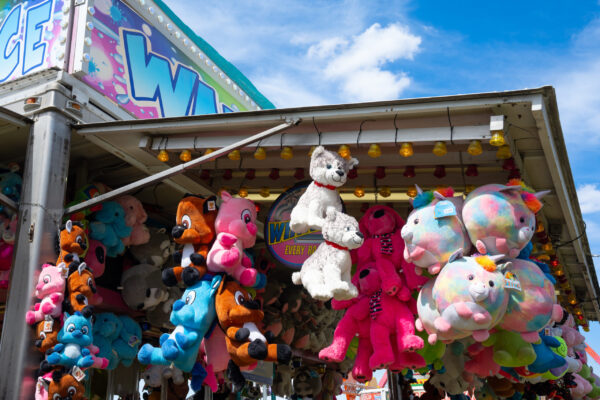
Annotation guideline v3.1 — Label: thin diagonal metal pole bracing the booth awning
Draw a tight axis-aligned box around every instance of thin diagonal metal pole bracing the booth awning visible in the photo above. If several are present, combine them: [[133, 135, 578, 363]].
[[65, 118, 300, 214]]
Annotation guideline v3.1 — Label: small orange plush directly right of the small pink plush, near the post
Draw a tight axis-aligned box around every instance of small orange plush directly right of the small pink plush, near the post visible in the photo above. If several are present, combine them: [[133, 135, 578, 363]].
[[66, 262, 102, 315]]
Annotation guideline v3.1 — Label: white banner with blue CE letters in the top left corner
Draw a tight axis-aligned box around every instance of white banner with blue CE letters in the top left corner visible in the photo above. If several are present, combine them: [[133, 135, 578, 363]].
[[0, 0, 69, 83]]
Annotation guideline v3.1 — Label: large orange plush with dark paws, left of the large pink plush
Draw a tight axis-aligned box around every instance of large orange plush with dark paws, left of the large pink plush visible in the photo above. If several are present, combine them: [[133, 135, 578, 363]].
[[162, 195, 217, 286]]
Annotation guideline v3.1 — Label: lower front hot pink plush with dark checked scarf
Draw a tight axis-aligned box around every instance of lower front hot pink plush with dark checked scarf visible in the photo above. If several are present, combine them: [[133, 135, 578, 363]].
[[355, 260, 425, 369]]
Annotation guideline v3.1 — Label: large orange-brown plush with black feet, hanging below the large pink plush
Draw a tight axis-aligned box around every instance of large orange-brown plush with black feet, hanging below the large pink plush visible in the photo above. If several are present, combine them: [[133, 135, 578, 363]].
[[215, 276, 292, 391]]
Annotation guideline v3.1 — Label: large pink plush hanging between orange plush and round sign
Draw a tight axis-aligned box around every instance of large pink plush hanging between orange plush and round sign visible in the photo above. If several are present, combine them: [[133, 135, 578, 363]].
[[206, 191, 266, 286]]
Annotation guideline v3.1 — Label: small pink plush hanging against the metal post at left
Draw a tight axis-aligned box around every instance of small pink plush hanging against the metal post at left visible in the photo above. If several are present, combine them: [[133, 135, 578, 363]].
[[25, 263, 67, 325]]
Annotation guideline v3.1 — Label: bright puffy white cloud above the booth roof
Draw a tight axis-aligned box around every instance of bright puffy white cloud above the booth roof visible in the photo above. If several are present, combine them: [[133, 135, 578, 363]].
[[307, 23, 421, 101]]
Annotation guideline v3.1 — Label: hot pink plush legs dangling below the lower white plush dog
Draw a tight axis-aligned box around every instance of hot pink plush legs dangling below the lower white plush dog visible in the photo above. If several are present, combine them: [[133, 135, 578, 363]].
[[319, 295, 373, 382]]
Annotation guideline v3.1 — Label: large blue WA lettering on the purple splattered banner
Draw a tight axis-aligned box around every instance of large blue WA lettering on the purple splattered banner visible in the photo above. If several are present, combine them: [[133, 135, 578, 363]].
[[121, 29, 218, 117]]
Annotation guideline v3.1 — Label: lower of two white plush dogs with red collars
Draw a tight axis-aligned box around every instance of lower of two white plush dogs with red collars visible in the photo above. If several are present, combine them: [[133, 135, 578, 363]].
[[292, 208, 364, 301]]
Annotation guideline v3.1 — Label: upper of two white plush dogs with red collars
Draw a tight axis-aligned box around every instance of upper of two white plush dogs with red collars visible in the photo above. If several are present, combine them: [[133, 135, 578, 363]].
[[290, 146, 358, 233]]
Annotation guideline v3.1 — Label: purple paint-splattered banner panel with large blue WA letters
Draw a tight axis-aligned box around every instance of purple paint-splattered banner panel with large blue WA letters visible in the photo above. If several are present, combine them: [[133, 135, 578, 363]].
[[82, 0, 247, 119]]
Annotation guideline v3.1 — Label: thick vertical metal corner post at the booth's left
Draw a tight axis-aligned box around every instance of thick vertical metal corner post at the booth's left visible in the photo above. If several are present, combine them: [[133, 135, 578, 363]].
[[0, 111, 71, 400]]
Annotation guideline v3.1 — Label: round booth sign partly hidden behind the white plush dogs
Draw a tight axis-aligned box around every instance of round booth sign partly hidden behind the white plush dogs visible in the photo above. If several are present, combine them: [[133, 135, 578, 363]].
[[265, 181, 323, 269]]
